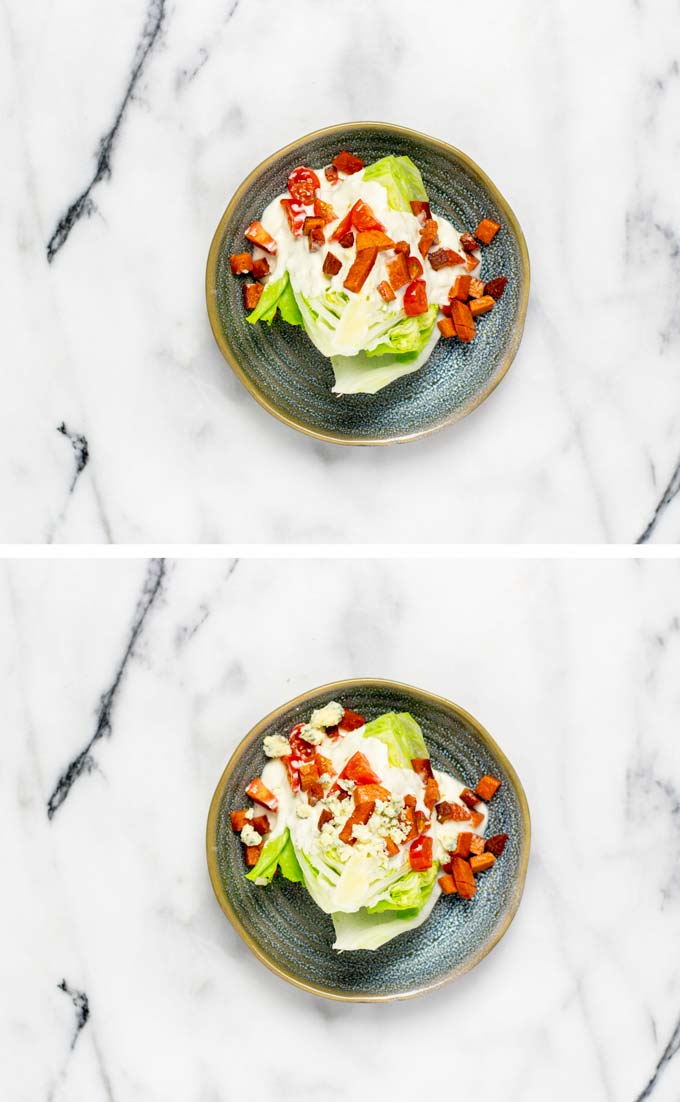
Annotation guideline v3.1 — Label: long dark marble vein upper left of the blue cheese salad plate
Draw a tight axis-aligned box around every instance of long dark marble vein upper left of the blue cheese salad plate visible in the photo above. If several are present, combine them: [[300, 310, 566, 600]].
[[47, 559, 165, 819]]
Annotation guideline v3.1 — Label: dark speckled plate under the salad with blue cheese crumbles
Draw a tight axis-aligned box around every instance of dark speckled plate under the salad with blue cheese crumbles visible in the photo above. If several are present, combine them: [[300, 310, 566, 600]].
[[206, 679, 530, 1002]]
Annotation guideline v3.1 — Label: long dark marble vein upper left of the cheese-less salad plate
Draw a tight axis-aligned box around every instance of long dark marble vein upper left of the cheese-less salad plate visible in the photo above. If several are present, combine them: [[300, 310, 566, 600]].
[[46, 0, 165, 263]]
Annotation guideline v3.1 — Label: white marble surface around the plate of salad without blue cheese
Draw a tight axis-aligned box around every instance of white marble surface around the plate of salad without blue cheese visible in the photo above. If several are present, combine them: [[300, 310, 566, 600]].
[[0, 0, 680, 542]]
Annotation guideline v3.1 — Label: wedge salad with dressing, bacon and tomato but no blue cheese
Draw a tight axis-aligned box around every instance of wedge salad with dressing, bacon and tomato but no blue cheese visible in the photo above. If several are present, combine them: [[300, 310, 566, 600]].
[[229, 150, 507, 395]]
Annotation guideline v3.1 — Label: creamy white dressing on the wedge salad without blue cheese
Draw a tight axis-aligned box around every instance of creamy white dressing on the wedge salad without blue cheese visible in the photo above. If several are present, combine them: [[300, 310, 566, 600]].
[[253, 169, 478, 357]]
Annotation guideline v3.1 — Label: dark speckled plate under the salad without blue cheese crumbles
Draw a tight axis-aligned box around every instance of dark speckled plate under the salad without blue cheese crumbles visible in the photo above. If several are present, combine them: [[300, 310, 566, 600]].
[[206, 122, 529, 444]]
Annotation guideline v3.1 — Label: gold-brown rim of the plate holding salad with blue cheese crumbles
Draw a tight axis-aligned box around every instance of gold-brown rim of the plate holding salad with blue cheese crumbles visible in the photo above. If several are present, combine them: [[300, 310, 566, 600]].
[[205, 678, 531, 1003]]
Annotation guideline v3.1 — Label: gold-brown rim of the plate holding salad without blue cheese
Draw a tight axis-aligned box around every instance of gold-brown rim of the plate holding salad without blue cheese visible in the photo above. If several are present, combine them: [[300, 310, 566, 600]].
[[205, 122, 530, 447]]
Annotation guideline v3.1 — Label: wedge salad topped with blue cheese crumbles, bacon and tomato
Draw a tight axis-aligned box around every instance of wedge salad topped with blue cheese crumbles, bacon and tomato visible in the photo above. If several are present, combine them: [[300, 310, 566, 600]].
[[230, 701, 507, 951]]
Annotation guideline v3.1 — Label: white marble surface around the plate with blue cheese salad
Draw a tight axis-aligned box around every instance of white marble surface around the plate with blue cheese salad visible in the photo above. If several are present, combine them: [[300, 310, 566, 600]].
[[0, 561, 680, 1102]]
